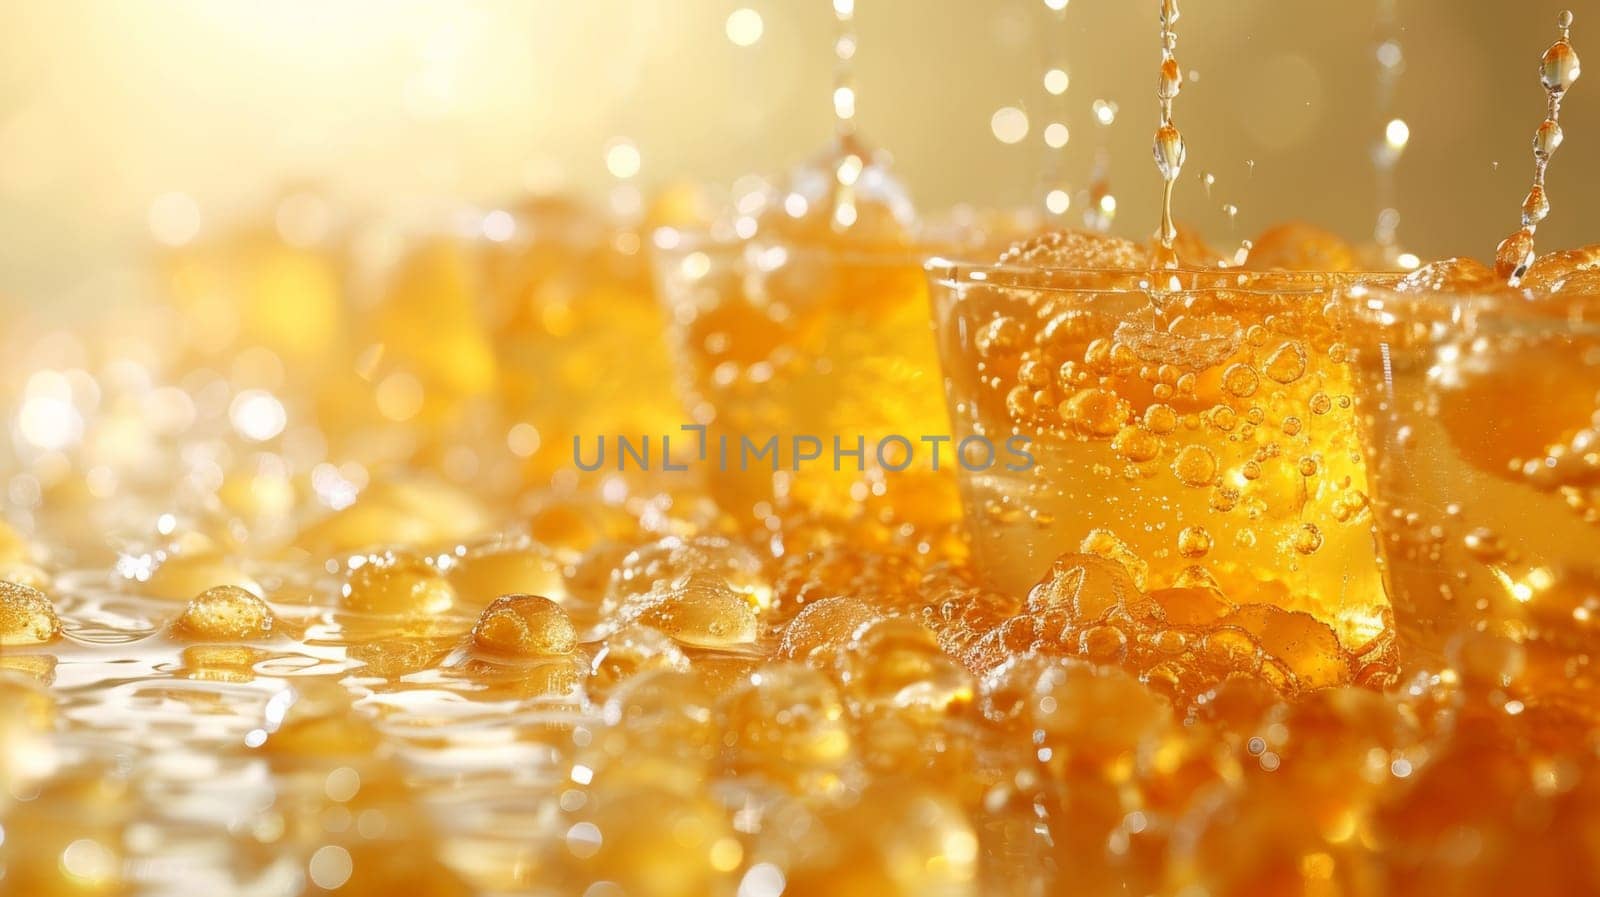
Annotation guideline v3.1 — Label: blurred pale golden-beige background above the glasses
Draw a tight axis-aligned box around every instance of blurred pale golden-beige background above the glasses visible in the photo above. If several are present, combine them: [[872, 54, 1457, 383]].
[[0, 0, 1600, 315]]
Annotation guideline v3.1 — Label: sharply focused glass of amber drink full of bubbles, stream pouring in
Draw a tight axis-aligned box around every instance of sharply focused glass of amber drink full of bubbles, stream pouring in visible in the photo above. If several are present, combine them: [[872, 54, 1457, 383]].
[[928, 261, 1387, 654]]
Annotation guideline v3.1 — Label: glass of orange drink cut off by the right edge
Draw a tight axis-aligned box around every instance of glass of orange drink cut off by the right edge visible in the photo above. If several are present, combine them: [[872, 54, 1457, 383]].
[[1344, 286, 1600, 678]]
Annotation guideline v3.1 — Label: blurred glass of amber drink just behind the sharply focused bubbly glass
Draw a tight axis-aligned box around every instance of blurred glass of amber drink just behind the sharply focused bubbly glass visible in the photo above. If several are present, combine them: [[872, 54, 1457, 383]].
[[654, 230, 954, 523]]
